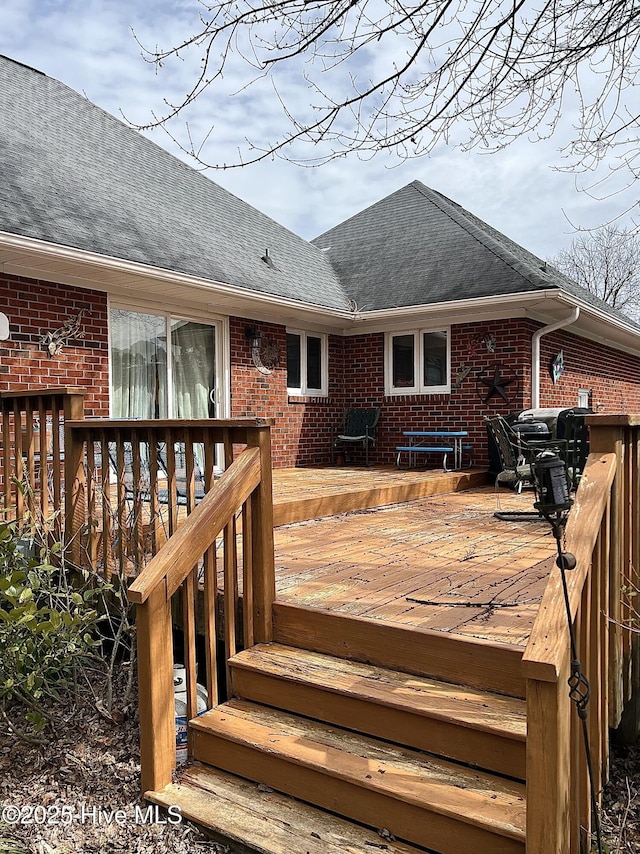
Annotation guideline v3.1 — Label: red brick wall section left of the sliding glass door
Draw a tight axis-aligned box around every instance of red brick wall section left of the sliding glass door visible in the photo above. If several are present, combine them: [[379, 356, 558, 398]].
[[0, 274, 109, 418]]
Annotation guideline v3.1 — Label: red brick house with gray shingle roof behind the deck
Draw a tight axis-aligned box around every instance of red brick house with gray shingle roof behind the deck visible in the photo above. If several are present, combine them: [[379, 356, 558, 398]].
[[0, 57, 640, 466]]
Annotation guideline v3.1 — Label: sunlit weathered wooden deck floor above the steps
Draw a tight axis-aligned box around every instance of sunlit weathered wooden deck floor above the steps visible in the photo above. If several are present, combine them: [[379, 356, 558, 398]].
[[274, 469, 555, 646]]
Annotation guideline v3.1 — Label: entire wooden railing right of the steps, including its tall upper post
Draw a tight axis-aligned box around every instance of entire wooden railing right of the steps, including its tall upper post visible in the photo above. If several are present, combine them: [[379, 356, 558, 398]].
[[523, 416, 640, 854]]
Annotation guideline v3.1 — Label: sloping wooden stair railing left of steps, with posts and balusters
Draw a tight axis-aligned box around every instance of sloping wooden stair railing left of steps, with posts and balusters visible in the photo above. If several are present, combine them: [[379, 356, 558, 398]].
[[124, 422, 275, 791]]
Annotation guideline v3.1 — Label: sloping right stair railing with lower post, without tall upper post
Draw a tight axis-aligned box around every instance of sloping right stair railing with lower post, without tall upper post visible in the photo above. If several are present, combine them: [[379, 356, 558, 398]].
[[522, 446, 624, 854]]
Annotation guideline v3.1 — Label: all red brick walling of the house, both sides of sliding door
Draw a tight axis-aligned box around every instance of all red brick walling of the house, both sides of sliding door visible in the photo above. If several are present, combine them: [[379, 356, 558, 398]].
[[0, 275, 640, 466]]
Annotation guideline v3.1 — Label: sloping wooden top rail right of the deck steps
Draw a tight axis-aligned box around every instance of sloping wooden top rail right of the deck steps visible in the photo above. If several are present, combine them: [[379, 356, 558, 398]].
[[522, 454, 616, 682]]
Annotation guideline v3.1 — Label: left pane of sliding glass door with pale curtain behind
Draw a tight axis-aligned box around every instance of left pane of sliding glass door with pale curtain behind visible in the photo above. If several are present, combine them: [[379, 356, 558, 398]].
[[111, 309, 168, 418]]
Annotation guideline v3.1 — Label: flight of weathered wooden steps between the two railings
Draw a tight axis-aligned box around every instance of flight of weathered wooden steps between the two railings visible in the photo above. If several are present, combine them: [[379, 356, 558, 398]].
[[147, 605, 526, 854]]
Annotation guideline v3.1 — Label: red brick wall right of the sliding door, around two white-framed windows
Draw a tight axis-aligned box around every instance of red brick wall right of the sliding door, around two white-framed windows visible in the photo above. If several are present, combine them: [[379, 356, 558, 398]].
[[231, 318, 640, 466]]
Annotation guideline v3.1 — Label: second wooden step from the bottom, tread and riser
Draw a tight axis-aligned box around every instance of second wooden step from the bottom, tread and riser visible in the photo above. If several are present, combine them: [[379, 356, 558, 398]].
[[190, 699, 525, 854]]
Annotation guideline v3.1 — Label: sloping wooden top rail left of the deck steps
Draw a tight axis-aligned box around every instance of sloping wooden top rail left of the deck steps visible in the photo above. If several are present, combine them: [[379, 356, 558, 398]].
[[128, 448, 261, 604]]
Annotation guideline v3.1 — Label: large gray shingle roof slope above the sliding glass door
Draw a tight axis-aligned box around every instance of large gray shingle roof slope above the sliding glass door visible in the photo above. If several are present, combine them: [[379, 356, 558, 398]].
[[0, 57, 345, 308]]
